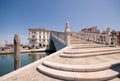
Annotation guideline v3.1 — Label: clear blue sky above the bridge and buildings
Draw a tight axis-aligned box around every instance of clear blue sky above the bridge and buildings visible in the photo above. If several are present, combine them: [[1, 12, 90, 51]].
[[0, 0, 120, 43]]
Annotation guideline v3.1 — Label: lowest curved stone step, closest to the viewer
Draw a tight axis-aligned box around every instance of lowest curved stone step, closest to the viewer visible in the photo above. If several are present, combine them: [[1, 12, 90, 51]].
[[37, 65, 119, 81]]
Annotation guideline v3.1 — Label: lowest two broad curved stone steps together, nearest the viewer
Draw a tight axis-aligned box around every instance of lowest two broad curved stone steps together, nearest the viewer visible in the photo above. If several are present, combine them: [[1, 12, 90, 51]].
[[37, 61, 120, 81]]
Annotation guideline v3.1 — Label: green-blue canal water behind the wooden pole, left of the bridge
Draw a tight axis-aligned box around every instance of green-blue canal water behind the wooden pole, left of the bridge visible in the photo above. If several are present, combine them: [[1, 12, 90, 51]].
[[0, 52, 50, 76]]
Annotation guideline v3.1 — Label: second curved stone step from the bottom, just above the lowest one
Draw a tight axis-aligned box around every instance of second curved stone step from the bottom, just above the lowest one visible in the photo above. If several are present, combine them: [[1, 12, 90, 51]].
[[42, 60, 120, 72]]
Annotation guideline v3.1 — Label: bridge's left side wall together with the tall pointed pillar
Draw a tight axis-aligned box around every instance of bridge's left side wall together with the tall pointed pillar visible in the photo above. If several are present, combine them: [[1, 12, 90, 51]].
[[49, 21, 70, 50]]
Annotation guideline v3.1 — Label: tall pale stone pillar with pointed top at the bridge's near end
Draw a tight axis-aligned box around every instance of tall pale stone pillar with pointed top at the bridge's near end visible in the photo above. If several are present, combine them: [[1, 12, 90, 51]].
[[65, 21, 70, 46]]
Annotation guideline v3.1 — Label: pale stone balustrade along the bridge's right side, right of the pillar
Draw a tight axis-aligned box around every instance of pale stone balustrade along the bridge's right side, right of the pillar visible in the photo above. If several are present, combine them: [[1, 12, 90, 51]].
[[72, 32, 116, 45]]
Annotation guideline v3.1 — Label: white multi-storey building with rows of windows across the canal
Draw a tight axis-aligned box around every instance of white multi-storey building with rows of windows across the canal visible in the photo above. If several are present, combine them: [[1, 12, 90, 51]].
[[28, 28, 50, 48]]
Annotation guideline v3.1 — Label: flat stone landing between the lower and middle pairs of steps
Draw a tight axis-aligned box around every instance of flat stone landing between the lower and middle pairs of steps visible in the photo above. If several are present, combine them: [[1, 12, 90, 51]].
[[48, 54, 120, 65]]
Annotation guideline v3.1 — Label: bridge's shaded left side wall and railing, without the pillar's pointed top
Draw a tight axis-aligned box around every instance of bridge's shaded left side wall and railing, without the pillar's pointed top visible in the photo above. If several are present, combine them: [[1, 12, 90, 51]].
[[49, 31, 70, 50]]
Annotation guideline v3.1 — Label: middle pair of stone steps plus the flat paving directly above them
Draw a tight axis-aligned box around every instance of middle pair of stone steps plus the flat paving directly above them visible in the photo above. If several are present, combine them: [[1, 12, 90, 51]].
[[60, 46, 120, 58]]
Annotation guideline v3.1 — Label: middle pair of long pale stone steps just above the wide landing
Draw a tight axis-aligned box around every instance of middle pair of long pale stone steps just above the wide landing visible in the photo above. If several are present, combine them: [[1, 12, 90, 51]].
[[60, 48, 120, 58]]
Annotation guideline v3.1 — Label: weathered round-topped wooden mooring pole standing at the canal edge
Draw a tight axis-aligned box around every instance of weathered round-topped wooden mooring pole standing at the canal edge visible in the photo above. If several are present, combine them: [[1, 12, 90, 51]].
[[14, 34, 20, 70]]
